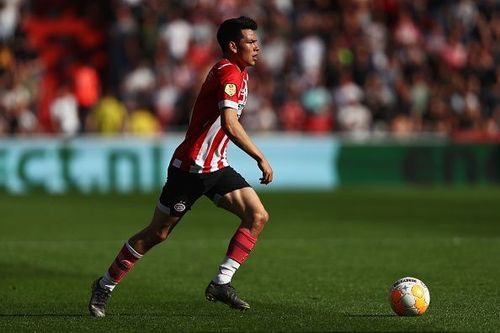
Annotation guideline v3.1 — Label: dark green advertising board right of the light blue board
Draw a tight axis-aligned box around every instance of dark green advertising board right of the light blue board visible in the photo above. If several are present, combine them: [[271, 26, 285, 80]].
[[336, 141, 500, 185]]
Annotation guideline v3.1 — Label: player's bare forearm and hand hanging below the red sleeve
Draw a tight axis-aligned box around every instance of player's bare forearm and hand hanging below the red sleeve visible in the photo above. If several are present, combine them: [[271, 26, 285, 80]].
[[221, 108, 273, 184]]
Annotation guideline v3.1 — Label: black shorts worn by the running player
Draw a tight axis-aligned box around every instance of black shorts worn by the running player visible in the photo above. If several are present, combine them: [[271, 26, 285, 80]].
[[157, 166, 250, 216]]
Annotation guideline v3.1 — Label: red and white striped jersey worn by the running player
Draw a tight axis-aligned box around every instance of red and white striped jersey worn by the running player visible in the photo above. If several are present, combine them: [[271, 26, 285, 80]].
[[170, 59, 248, 173]]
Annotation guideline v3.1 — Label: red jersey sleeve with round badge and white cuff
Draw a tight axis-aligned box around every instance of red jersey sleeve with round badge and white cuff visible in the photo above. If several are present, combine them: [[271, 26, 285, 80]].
[[217, 65, 241, 110]]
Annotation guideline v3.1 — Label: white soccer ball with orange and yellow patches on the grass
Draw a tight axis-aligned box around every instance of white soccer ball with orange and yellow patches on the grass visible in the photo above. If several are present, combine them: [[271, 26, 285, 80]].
[[389, 277, 431, 316]]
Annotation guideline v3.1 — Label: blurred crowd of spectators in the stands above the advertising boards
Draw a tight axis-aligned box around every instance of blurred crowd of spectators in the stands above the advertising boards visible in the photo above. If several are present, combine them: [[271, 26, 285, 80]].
[[0, 0, 500, 140]]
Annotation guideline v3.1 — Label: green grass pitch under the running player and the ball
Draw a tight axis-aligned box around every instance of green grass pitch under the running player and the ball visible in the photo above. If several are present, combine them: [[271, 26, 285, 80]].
[[0, 188, 500, 332]]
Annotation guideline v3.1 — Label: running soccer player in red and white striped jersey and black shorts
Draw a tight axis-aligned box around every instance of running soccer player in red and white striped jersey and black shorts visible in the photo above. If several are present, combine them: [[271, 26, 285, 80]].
[[89, 16, 273, 317]]
